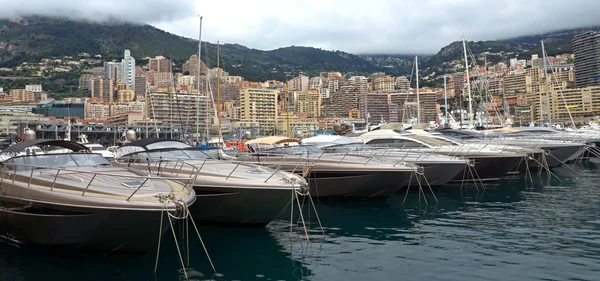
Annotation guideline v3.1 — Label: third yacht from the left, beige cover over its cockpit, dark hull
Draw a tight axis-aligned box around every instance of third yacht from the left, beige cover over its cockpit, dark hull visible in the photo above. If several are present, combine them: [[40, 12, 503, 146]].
[[238, 136, 420, 199]]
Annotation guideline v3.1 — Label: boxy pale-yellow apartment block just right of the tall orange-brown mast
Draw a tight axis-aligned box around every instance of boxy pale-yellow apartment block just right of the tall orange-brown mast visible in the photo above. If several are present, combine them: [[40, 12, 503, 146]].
[[240, 88, 279, 131]]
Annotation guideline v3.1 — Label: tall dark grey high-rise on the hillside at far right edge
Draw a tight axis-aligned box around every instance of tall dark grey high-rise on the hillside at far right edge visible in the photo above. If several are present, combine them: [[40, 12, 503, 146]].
[[573, 31, 600, 87]]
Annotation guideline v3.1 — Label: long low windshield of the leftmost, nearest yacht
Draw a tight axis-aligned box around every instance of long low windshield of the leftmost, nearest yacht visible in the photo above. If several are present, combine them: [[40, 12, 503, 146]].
[[7, 153, 111, 171]]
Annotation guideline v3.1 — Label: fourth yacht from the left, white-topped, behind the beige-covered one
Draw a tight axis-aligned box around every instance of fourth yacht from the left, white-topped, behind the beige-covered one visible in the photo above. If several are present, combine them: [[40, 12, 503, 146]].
[[302, 135, 469, 186]]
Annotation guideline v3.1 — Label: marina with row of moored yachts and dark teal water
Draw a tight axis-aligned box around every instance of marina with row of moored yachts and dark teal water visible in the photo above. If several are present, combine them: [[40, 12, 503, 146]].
[[0, 124, 600, 280]]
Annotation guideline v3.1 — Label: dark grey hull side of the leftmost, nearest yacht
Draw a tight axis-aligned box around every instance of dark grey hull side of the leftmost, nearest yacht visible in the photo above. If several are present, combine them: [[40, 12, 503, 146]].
[[0, 197, 169, 253]]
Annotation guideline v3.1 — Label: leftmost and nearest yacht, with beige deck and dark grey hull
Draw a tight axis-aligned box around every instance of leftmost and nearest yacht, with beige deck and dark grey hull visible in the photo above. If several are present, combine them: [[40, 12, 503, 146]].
[[0, 140, 195, 253]]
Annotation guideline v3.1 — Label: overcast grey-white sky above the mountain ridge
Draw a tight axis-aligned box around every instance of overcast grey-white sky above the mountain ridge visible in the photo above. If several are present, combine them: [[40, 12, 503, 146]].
[[0, 0, 600, 54]]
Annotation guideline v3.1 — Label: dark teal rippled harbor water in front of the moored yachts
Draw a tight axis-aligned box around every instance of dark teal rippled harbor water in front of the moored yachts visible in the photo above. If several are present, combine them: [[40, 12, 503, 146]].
[[0, 159, 600, 281]]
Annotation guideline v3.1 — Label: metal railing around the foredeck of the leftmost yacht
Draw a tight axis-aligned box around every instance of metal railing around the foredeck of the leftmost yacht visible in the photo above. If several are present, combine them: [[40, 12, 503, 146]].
[[0, 163, 195, 201]]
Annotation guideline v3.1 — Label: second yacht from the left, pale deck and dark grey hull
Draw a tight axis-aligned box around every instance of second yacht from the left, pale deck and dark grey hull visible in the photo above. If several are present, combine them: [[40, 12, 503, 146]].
[[115, 138, 308, 227]]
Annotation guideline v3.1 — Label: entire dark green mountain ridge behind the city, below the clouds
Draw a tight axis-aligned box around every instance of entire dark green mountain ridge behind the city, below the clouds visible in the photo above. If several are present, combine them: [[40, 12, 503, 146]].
[[0, 16, 600, 82]]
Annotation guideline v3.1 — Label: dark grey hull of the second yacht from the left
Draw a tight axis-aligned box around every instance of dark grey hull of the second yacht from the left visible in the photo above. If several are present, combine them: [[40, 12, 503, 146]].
[[190, 186, 295, 227]]
